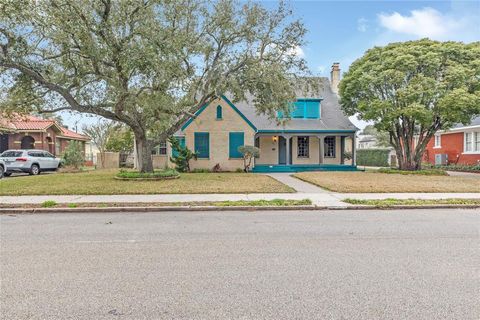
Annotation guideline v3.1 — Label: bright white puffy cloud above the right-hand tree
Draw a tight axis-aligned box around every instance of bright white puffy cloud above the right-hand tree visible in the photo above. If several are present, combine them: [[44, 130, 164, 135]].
[[378, 7, 462, 38]]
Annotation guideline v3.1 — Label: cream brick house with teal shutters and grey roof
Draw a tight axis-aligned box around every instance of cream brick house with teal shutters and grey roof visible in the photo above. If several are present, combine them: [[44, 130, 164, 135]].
[[153, 63, 358, 172]]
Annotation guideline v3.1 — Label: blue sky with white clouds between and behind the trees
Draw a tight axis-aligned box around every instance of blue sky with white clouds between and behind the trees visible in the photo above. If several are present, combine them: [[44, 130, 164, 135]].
[[64, 0, 480, 128]]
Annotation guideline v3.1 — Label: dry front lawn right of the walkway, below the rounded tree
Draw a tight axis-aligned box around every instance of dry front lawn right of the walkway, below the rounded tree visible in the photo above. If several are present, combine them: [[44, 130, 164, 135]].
[[294, 172, 480, 193]]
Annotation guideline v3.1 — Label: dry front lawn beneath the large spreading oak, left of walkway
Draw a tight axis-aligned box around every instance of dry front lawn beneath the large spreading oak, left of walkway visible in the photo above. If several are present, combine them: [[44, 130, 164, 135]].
[[0, 170, 294, 196]]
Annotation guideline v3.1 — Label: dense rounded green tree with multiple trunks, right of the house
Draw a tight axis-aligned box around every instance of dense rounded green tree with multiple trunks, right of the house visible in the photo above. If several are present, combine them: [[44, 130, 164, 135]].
[[339, 39, 480, 170]]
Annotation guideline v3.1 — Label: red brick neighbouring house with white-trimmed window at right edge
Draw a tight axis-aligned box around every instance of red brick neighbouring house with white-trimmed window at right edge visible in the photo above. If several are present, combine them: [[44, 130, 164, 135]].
[[424, 117, 480, 165]]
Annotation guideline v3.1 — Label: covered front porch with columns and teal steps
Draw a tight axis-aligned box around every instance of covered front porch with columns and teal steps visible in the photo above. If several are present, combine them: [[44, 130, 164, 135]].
[[253, 131, 356, 172]]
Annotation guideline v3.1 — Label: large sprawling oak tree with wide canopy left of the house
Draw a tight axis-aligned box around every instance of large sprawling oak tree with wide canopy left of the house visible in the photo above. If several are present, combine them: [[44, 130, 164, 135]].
[[0, 0, 307, 171]]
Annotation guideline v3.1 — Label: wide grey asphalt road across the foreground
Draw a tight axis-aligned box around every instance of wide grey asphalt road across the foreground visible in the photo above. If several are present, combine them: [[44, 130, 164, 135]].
[[0, 210, 480, 320]]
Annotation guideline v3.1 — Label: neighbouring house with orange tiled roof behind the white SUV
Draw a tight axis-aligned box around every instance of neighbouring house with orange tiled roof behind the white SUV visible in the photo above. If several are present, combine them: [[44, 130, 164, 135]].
[[0, 115, 90, 156]]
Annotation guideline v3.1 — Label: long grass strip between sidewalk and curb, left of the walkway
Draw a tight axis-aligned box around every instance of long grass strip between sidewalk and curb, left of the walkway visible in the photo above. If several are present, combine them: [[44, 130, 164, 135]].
[[0, 199, 312, 209]]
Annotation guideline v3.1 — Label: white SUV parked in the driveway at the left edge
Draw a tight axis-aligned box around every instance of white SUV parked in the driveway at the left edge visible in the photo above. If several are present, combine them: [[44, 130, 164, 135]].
[[0, 149, 60, 177]]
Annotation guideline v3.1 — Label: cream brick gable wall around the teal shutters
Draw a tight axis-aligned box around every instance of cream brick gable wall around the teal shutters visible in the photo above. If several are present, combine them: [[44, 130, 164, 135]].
[[184, 99, 255, 171]]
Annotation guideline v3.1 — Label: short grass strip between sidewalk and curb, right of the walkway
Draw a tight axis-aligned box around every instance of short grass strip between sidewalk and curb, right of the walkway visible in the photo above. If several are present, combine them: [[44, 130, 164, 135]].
[[343, 198, 480, 207]]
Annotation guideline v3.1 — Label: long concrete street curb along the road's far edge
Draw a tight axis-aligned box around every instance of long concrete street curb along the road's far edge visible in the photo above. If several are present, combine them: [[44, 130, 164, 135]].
[[0, 204, 480, 215]]
